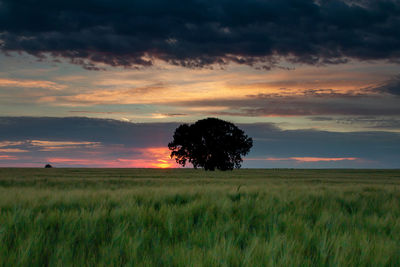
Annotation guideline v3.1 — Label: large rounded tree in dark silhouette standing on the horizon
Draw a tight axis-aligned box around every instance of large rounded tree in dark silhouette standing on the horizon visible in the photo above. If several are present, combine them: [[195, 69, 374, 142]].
[[168, 118, 253, 171]]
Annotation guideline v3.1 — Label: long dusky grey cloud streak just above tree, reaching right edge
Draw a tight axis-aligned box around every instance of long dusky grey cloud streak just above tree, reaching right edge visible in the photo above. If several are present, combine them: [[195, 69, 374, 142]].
[[171, 94, 400, 117]]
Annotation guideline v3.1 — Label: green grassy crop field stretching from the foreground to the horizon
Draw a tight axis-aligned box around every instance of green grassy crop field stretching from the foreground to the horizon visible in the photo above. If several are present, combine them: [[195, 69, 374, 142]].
[[0, 169, 400, 266]]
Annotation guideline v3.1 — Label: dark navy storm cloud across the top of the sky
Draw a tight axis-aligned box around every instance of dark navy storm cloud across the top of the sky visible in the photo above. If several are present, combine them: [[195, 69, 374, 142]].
[[0, 0, 400, 69]]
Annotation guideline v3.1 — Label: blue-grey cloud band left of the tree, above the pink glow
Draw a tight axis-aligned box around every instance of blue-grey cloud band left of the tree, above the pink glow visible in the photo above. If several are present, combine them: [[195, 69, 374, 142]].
[[0, 117, 178, 148]]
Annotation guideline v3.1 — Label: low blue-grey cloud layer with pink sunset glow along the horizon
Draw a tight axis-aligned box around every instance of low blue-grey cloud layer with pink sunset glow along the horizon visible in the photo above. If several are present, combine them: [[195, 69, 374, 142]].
[[0, 117, 400, 168]]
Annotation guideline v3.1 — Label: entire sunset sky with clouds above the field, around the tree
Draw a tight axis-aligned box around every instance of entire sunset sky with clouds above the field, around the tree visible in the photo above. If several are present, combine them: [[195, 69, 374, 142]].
[[0, 0, 400, 168]]
